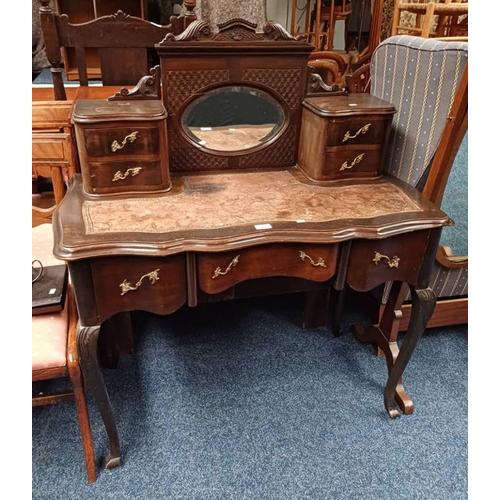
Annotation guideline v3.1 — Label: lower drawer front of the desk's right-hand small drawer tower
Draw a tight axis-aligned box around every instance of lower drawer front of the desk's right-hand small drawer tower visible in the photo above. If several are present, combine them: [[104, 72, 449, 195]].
[[322, 146, 382, 180]]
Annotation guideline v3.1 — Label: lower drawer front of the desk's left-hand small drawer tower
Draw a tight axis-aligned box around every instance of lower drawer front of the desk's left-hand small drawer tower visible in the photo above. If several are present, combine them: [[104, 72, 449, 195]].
[[83, 161, 169, 194]]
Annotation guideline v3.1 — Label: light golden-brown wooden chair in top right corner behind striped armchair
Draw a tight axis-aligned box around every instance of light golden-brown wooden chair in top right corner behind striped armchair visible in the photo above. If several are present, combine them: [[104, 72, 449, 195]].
[[391, 0, 469, 38]]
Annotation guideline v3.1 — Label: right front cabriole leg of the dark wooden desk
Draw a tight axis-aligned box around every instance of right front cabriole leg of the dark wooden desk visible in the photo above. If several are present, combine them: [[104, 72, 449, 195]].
[[384, 286, 436, 418]]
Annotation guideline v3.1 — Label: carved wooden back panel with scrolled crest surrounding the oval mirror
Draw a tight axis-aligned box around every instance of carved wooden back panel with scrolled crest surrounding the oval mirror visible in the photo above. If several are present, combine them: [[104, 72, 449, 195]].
[[156, 20, 313, 172]]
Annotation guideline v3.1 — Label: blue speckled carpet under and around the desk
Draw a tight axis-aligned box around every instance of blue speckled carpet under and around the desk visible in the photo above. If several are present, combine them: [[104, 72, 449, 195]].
[[32, 295, 468, 500]]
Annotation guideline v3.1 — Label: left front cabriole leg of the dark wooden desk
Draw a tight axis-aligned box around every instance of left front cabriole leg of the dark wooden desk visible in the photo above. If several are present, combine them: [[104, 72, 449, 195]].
[[77, 324, 120, 468]]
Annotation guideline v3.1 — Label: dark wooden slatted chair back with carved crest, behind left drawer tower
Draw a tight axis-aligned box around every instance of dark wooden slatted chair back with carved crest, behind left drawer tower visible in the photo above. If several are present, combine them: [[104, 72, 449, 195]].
[[39, 0, 196, 100]]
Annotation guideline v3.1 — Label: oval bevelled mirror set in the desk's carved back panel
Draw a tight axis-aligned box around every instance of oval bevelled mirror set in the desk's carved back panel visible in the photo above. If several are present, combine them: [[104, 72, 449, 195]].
[[181, 86, 285, 151]]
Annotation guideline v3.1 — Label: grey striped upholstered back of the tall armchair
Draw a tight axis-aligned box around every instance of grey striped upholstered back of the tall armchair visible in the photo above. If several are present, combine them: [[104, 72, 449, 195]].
[[370, 35, 468, 190]]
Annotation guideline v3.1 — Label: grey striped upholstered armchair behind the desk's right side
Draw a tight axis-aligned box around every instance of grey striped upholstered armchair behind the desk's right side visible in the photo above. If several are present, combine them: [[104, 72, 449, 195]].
[[362, 35, 468, 331]]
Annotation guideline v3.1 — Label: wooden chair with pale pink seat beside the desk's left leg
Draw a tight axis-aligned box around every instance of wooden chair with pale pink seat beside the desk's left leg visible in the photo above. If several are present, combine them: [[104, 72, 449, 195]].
[[31, 223, 96, 482]]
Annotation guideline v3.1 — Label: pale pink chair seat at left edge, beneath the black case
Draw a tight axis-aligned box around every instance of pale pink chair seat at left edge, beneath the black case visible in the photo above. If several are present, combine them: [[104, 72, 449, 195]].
[[31, 224, 70, 370]]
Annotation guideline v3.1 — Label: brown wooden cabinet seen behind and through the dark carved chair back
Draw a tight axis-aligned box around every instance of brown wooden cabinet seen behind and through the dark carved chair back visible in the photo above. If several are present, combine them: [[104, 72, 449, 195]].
[[55, 0, 147, 81]]
